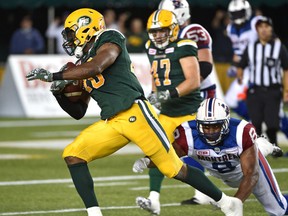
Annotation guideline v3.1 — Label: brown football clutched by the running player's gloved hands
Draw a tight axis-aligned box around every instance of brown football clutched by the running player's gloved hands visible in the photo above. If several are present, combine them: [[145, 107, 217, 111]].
[[62, 62, 87, 102]]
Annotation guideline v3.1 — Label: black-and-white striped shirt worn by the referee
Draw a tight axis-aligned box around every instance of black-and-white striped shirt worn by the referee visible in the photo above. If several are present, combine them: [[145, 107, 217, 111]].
[[238, 38, 288, 87]]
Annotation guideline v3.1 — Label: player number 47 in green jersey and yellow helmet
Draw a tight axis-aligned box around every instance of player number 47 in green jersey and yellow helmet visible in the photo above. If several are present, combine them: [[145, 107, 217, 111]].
[[136, 10, 203, 214]]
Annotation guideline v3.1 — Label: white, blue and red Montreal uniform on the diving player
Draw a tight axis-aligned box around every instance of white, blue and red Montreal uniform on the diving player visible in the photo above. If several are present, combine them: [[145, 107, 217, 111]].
[[175, 118, 288, 215]]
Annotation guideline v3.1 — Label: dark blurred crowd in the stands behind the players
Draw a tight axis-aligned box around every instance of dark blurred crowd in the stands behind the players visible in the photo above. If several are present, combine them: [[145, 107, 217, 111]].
[[0, 0, 288, 90]]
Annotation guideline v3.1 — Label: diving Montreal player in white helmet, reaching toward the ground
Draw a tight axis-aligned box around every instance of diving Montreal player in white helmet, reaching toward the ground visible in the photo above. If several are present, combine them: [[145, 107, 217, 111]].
[[133, 98, 288, 216]]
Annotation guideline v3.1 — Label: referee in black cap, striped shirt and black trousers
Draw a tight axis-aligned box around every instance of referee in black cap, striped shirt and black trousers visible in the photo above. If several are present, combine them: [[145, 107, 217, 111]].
[[237, 16, 288, 145]]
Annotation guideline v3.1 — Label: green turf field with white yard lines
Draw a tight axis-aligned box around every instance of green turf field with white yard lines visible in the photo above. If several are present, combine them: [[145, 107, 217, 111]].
[[0, 118, 288, 216]]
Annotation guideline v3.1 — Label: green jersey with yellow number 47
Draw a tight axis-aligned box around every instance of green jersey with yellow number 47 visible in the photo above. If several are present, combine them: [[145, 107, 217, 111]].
[[146, 39, 202, 117]]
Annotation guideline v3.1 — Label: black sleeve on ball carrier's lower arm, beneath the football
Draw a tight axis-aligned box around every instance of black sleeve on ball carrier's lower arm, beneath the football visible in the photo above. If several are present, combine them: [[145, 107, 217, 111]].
[[53, 94, 88, 120]]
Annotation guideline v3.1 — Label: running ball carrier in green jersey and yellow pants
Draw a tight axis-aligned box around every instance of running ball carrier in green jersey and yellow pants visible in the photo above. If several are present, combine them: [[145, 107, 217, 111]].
[[26, 8, 241, 216]]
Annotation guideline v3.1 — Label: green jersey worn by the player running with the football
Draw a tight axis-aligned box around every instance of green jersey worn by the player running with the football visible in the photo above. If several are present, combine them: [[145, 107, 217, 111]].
[[84, 30, 144, 119]]
